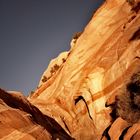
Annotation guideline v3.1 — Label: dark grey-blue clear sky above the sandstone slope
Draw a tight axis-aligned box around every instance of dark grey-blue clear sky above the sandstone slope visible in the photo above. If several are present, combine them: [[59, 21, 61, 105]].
[[0, 0, 103, 95]]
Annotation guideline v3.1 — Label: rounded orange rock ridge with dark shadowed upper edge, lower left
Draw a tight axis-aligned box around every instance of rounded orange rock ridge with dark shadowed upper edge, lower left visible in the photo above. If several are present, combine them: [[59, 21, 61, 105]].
[[0, 89, 72, 140]]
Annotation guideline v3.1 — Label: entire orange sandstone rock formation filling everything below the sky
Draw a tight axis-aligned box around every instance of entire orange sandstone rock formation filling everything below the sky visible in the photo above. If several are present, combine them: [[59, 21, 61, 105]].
[[0, 0, 140, 140]]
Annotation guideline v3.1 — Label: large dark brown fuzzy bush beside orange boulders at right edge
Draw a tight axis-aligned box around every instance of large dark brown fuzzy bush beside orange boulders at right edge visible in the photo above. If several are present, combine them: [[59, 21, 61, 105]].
[[110, 72, 140, 124]]
